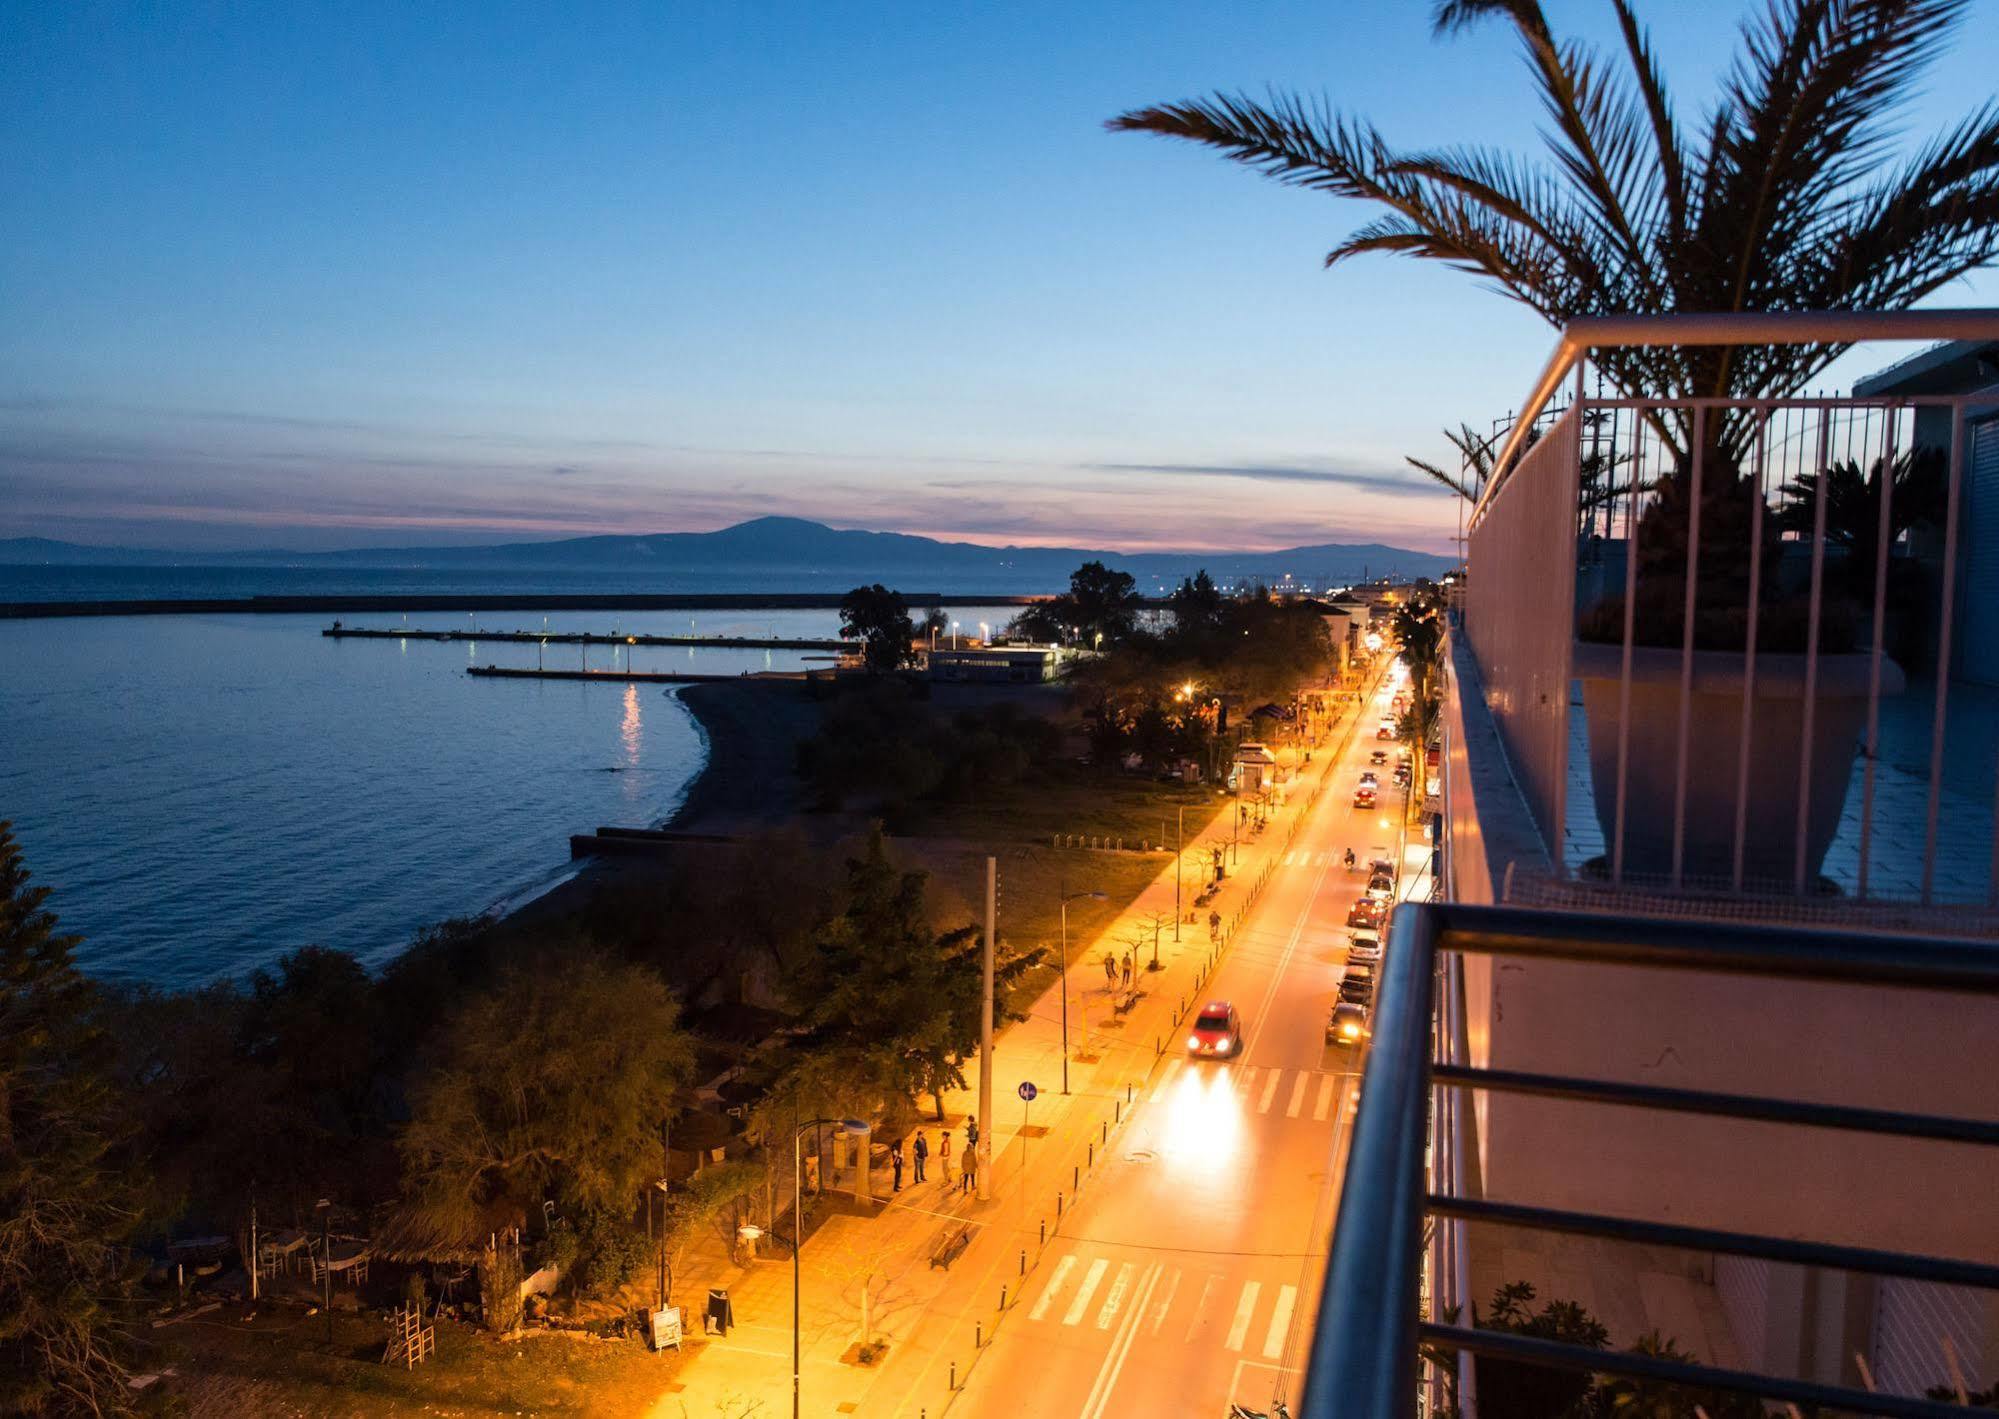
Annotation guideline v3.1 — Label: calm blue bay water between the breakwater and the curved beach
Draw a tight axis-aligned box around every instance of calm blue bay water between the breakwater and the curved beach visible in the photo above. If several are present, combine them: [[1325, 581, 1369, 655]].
[[0, 595, 1009, 985]]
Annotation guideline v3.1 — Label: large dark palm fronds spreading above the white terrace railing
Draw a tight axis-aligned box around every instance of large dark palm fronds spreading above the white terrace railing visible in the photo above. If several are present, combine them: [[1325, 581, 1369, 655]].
[[1109, 0, 1999, 457]]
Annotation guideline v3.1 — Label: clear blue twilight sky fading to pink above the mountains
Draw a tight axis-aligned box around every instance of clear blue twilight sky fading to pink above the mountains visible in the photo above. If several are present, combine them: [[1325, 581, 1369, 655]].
[[0, 0, 1999, 550]]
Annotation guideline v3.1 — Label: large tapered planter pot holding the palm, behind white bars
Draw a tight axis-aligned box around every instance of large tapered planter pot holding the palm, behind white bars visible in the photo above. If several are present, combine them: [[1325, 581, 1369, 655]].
[[1573, 642, 1905, 887]]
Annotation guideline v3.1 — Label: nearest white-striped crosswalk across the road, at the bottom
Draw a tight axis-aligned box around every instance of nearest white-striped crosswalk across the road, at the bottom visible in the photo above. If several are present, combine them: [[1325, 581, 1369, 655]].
[[1027, 1251, 1297, 1361]]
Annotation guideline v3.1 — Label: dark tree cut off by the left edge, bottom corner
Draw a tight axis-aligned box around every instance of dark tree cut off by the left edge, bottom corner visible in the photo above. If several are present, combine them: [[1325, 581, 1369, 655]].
[[0, 821, 138, 1415]]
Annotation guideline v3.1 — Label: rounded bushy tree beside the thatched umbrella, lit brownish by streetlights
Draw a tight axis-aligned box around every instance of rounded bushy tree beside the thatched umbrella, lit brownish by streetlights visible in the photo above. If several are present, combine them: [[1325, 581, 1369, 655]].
[[400, 955, 694, 1237]]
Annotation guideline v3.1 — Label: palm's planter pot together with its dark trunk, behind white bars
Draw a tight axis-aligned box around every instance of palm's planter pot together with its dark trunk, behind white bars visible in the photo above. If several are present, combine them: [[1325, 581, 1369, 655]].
[[1573, 432, 1905, 885]]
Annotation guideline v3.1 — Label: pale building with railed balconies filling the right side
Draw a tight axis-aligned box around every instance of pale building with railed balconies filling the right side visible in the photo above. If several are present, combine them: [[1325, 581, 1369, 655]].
[[1303, 312, 1999, 1419]]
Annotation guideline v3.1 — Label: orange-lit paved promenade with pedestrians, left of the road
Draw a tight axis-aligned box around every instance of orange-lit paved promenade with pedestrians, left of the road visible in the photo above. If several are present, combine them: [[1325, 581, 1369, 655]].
[[650, 667, 1399, 1419]]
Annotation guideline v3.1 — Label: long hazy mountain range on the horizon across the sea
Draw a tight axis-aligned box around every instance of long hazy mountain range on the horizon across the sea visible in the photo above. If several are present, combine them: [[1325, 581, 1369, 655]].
[[0, 518, 1451, 592]]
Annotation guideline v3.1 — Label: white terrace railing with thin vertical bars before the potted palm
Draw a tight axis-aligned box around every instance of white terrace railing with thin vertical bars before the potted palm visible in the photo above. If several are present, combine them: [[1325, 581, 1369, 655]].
[[1463, 310, 1999, 915]]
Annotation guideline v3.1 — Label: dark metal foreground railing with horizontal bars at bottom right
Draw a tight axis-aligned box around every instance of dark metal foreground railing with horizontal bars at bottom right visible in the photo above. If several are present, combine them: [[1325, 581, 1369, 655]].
[[1299, 901, 1999, 1419]]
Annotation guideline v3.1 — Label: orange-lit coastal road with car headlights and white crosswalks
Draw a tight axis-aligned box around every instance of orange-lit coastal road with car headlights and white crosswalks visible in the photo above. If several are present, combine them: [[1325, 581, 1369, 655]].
[[952, 671, 1401, 1419]]
